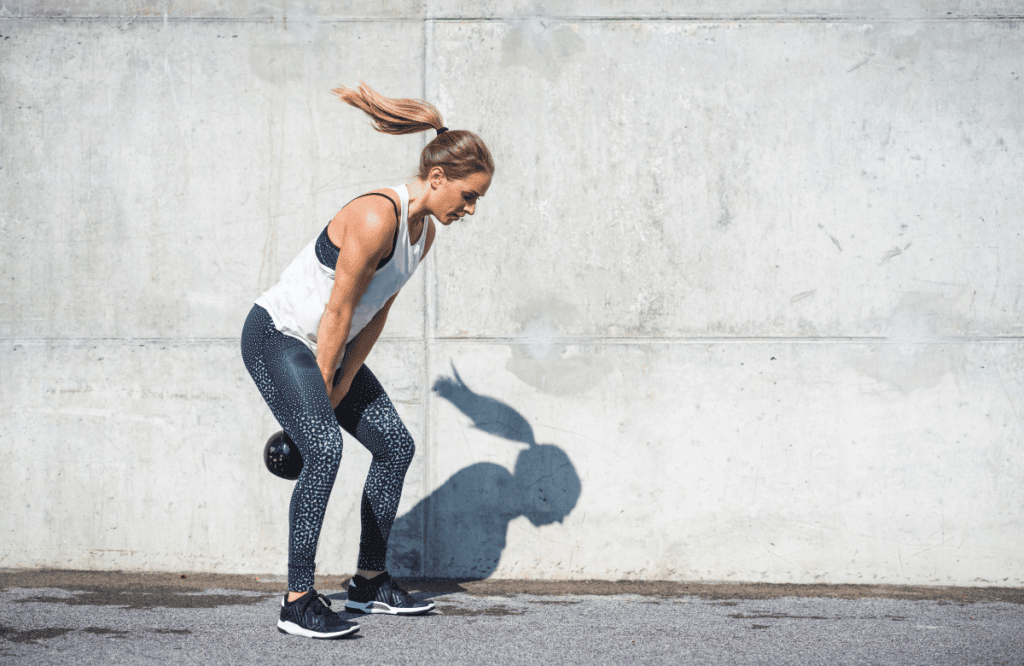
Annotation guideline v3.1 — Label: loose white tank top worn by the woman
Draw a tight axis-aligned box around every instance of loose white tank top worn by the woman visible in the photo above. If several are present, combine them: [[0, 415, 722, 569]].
[[256, 185, 427, 366]]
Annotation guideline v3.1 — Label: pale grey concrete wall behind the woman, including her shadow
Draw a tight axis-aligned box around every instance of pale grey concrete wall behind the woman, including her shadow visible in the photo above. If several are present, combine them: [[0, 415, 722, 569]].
[[0, 0, 1024, 586]]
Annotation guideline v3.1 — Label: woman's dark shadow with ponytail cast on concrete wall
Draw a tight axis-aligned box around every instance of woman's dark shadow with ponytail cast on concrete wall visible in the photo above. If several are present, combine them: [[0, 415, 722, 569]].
[[388, 365, 581, 579]]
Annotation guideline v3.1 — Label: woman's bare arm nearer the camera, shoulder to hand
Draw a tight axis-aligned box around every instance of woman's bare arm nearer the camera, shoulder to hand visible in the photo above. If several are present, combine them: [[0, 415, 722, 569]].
[[316, 197, 398, 394]]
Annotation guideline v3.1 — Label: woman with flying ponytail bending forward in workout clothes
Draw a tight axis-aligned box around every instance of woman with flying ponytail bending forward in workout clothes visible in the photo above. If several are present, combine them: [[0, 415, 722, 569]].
[[242, 83, 495, 638]]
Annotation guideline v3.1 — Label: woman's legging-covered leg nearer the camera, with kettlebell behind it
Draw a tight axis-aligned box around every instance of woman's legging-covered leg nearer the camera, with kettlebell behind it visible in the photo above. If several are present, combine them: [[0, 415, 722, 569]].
[[242, 305, 342, 592]]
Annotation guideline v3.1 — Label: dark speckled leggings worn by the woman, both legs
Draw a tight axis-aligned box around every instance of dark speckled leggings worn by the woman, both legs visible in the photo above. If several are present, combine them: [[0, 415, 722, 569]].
[[242, 305, 416, 592]]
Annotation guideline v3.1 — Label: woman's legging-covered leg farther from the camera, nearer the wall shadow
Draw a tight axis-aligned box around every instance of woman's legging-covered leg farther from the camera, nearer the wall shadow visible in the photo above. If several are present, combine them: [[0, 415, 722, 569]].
[[334, 366, 416, 572]]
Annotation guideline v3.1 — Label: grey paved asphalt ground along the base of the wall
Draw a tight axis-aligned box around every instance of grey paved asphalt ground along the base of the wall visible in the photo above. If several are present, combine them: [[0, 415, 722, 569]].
[[0, 572, 1024, 666]]
